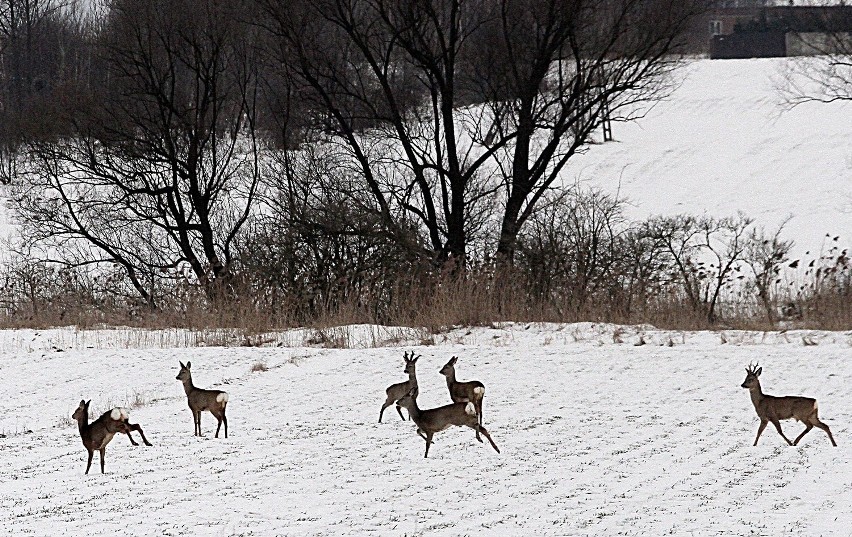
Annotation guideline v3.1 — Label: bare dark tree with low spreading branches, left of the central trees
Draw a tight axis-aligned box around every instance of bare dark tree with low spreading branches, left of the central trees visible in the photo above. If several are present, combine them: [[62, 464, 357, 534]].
[[17, 0, 262, 303]]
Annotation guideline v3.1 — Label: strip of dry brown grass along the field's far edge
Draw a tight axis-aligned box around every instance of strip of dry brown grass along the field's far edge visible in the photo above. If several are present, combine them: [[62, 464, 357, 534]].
[[0, 260, 852, 336]]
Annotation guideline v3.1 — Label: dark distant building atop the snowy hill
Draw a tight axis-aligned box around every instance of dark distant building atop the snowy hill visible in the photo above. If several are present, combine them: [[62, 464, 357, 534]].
[[691, 0, 852, 59]]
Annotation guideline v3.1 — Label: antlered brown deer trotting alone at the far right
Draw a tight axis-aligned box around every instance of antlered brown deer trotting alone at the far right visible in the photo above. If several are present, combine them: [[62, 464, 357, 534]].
[[742, 364, 837, 447]]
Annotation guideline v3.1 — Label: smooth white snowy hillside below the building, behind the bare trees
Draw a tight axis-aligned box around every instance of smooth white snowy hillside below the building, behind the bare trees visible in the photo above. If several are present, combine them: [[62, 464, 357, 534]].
[[564, 58, 852, 254]]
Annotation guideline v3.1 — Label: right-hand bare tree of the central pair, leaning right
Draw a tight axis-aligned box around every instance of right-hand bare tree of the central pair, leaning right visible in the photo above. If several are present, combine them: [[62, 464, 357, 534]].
[[472, 0, 705, 259]]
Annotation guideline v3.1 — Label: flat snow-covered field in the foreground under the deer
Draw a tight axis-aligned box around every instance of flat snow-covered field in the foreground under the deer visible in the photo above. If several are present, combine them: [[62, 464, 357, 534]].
[[0, 324, 852, 536]]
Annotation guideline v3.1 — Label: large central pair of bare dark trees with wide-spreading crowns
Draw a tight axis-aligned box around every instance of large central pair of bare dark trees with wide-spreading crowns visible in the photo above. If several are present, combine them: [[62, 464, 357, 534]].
[[258, 0, 703, 260]]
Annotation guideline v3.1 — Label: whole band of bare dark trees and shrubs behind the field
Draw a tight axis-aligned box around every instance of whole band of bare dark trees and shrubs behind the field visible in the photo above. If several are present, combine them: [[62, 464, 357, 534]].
[[0, 0, 844, 326]]
